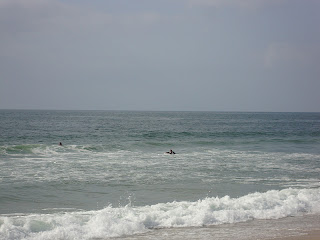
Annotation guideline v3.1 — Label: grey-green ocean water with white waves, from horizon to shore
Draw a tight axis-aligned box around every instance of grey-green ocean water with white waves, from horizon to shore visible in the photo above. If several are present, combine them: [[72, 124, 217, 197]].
[[0, 110, 320, 239]]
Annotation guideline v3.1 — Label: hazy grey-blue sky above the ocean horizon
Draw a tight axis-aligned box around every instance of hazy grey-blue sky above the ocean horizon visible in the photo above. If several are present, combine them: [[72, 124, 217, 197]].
[[0, 0, 320, 112]]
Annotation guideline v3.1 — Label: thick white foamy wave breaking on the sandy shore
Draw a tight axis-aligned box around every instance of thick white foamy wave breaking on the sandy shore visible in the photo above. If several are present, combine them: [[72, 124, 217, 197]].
[[0, 189, 320, 239]]
